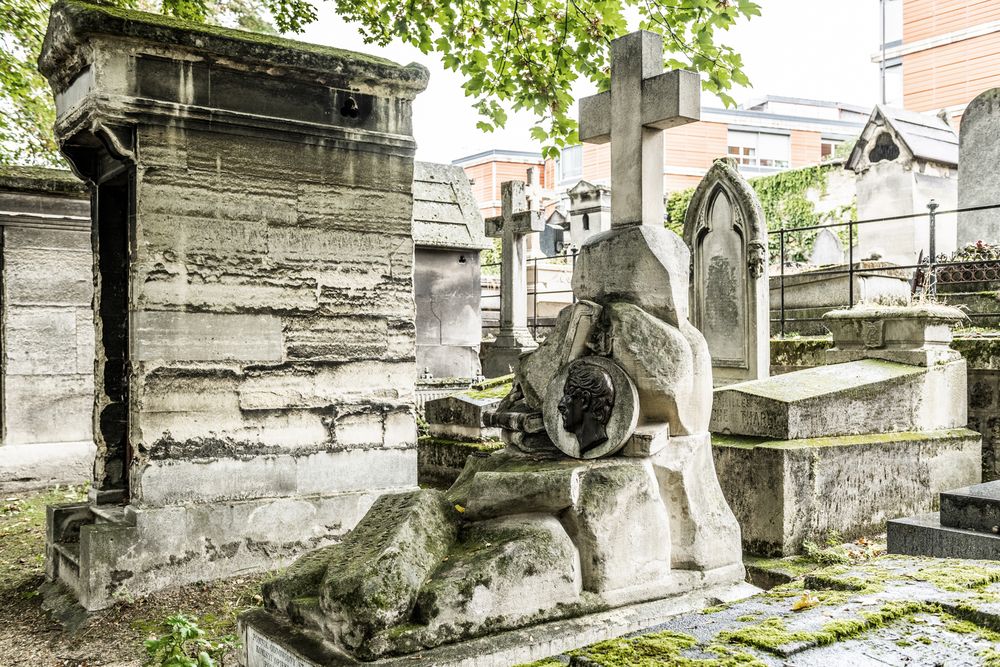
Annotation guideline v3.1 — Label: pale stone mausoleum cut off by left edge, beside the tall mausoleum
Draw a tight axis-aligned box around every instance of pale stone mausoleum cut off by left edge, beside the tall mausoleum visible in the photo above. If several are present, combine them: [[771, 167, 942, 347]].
[[0, 167, 94, 491]]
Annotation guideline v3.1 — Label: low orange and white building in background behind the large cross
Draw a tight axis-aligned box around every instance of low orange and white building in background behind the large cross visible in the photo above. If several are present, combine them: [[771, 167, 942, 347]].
[[453, 96, 868, 217]]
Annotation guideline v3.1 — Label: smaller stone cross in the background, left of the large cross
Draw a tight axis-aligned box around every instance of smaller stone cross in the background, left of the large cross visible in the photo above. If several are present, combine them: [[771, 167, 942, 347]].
[[486, 181, 545, 347]]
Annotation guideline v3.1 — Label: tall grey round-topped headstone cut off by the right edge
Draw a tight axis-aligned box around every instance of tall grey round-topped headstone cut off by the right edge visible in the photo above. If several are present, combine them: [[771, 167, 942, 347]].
[[952, 88, 1000, 248]]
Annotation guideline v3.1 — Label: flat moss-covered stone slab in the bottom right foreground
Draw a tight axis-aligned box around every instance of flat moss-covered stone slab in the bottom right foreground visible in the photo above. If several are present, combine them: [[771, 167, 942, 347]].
[[536, 556, 1000, 667]]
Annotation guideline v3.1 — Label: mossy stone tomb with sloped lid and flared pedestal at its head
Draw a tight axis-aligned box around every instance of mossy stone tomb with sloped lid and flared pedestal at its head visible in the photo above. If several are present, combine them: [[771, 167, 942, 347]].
[[712, 305, 982, 555]]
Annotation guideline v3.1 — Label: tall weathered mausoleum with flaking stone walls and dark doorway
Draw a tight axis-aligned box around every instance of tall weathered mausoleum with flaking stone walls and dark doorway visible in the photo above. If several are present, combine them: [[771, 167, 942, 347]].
[[40, 2, 427, 609]]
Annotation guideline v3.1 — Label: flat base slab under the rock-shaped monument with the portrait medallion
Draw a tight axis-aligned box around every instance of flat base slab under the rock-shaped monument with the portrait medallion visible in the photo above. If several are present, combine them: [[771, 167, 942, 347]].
[[239, 583, 759, 667]]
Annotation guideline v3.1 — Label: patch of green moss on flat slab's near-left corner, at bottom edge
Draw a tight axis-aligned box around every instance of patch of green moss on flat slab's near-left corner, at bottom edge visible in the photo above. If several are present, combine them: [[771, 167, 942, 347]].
[[570, 630, 764, 667]]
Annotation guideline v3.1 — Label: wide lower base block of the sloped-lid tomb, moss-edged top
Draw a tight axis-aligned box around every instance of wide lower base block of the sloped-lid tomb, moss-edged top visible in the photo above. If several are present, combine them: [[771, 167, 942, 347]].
[[713, 429, 982, 557]]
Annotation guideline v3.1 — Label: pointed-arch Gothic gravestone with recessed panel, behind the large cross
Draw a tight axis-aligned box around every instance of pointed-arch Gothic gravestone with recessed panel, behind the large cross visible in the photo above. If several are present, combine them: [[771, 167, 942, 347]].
[[684, 159, 770, 386]]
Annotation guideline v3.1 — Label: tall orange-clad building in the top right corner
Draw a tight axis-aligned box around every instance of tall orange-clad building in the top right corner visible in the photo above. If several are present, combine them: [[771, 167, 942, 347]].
[[873, 0, 1000, 128]]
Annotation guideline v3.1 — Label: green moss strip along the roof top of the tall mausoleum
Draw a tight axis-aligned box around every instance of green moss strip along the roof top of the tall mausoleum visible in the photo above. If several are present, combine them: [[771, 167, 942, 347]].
[[63, 0, 399, 67]]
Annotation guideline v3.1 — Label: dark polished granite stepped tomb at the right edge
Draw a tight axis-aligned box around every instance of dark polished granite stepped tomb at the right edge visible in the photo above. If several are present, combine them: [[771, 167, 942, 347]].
[[887, 480, 1000, 560]]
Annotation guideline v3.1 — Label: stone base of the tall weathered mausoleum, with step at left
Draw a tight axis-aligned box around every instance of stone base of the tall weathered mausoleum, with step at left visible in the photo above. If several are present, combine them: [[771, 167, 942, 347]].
[[46, 480, 406, 611]]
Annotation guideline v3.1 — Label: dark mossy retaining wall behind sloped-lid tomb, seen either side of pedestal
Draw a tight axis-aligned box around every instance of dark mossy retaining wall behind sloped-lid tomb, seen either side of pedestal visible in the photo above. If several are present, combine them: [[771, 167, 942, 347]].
[[771, 335, 1000, 482]]
